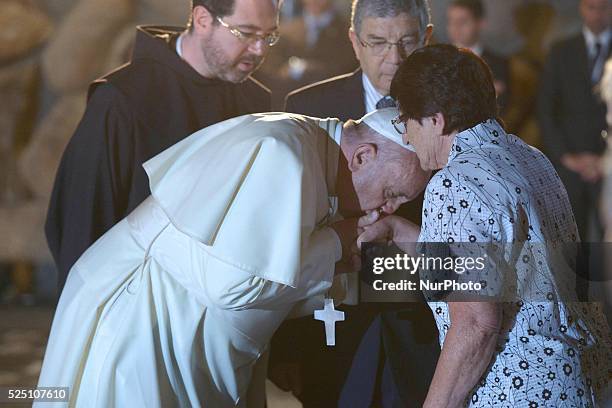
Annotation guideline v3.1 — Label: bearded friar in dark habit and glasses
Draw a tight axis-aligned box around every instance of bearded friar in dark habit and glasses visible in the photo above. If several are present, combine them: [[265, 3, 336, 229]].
[[45, 0, 280, 289]]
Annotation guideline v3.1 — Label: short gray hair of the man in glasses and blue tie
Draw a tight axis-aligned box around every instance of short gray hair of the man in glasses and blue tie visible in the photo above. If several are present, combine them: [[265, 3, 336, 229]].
[[351, 0, 431, 39]]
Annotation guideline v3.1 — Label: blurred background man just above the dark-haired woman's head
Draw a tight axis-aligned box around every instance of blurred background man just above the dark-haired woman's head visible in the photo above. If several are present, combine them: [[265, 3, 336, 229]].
[[446, 0, 510, 117]]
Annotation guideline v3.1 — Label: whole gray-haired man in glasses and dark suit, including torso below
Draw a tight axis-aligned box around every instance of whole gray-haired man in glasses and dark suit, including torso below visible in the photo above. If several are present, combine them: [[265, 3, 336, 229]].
[[271, 0, 439, 408]]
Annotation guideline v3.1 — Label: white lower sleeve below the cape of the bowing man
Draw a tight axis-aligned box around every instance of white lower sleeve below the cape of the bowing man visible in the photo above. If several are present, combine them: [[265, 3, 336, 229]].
[[202, 227, 342, 310]]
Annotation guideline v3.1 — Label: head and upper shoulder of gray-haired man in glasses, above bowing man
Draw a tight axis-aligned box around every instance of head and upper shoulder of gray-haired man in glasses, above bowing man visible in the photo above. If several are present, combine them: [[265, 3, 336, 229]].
[[285, 0, 433, 119]]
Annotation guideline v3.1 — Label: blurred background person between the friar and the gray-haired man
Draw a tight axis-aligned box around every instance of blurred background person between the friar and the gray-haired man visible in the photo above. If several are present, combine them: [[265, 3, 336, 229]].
[[257, 0, 357, 110]]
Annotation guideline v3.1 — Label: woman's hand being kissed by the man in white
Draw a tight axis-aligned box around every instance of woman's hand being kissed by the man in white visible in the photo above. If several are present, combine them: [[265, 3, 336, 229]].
[[357, 215, 421, 255]]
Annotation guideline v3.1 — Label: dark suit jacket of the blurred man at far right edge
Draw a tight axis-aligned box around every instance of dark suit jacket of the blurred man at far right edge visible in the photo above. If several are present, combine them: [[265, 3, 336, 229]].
[[538, 33, 610, 165]]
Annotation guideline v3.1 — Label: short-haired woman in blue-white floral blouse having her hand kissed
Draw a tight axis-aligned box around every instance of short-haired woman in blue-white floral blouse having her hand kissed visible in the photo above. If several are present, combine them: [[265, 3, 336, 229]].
[[359, 45, 612, 407]]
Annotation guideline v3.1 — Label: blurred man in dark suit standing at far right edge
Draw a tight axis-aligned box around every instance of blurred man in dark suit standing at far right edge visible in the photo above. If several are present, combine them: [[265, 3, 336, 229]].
[[538, 0, 612, 241]]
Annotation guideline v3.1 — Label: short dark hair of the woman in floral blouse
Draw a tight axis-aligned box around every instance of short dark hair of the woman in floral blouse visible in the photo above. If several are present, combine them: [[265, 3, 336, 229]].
[[391, 44, 499, 134]]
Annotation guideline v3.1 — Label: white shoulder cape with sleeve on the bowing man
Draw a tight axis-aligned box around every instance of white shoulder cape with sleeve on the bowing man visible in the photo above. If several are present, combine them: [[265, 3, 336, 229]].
[[144, 114, 341, 310]]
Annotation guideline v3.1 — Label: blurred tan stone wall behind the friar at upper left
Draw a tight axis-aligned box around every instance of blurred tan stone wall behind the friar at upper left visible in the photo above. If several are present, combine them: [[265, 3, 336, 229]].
[[0, 0, 190, 263]]
